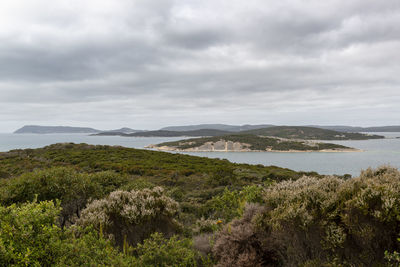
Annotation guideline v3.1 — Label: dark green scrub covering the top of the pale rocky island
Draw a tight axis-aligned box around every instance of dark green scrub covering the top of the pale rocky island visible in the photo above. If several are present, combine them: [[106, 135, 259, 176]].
[[156, 134, 351, 151]]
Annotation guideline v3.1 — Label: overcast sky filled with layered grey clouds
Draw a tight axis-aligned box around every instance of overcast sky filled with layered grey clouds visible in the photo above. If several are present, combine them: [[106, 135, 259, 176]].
[[0, 0, 400, 132]]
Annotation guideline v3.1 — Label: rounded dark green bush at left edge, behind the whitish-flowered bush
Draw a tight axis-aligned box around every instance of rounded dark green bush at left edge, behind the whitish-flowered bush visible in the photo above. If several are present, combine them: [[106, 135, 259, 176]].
[[0, 167, 128, 227]]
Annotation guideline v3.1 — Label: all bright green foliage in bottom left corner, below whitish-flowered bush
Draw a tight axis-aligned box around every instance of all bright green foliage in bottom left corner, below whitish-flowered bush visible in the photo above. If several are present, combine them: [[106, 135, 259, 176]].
[[0, 201, 132, 266]]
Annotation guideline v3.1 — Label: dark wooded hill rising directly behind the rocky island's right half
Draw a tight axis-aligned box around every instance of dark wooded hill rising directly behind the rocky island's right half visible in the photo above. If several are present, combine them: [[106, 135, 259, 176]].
[[241, 126, 384, 140]]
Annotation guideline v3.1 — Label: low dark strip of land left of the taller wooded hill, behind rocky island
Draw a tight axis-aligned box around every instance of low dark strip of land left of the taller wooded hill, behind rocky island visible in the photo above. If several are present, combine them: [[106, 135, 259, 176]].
[[93, 129, 231, 137]]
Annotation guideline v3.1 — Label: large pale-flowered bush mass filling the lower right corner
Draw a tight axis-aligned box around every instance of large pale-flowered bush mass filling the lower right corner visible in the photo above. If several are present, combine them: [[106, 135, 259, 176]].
[[216, 166, 400, 266]]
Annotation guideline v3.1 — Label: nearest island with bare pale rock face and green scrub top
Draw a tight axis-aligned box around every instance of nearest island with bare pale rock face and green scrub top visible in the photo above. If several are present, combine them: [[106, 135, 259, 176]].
[[147, 134, 360, 152]]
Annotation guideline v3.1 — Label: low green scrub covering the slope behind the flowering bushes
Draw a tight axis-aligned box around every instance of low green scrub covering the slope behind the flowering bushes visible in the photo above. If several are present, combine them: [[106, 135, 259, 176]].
[[0, 144, 311, 225]]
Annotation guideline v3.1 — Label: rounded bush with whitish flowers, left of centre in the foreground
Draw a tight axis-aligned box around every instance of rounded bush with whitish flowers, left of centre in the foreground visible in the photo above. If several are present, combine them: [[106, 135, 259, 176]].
[[77, 187, 178, 247]]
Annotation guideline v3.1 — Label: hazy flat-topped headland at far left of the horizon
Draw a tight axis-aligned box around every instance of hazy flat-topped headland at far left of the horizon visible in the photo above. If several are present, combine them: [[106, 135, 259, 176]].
[[14, 125, 101, 134]]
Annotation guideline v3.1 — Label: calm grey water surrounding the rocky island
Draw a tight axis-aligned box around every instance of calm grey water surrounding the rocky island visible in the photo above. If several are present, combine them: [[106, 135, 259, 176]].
[[0, 133, 400, 176]]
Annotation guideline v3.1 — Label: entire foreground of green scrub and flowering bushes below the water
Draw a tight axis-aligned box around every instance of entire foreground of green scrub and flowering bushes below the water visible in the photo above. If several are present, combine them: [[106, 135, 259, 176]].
[[0, 144, 400, 266]]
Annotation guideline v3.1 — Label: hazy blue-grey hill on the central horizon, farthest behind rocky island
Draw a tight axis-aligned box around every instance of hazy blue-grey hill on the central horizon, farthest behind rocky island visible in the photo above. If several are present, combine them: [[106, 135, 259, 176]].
[[160, 124, 274, 132]]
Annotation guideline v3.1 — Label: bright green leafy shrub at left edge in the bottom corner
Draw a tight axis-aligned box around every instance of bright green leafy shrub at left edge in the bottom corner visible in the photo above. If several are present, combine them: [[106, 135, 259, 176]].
[[0, 201, 62, 266]]
